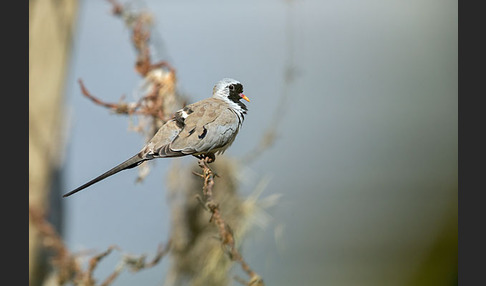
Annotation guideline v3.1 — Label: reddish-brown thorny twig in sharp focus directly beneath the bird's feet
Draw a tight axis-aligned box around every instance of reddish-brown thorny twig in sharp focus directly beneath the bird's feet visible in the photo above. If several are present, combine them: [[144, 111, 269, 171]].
[[195, 157, 264, 286]]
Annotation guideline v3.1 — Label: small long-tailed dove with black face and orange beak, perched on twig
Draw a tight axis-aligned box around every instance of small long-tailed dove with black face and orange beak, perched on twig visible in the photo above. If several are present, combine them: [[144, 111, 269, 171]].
[[63, 78, 250, 197]]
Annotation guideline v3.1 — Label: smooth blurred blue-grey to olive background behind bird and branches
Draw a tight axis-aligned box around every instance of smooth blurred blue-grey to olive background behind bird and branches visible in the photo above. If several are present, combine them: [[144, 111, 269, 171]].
[[29, 0, 458, 285]]
